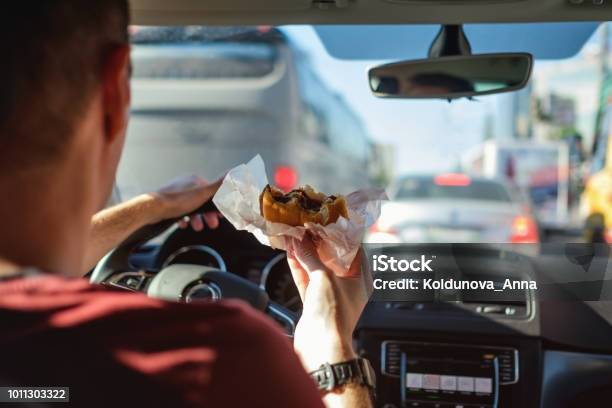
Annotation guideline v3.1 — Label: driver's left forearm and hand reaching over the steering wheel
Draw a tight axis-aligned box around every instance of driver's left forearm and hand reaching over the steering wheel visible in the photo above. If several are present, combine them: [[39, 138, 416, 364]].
[[82, 176, 222, 273]]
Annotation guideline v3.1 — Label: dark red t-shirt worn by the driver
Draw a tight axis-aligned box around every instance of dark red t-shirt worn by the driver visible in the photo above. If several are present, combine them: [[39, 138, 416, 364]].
[[0, 275, 323, 408]]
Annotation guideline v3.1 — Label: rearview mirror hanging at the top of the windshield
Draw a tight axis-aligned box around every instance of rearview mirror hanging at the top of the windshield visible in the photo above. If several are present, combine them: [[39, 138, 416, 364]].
[[368, 53, 533, 99]]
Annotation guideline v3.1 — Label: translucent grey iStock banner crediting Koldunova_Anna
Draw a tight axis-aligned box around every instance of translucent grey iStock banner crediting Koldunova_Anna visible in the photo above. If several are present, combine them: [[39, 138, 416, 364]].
[[363, 243, 612, 304]]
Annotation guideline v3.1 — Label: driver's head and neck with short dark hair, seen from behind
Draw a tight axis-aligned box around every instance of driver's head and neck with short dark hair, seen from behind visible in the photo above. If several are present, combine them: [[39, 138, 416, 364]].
[[0, 0, 130, 274]]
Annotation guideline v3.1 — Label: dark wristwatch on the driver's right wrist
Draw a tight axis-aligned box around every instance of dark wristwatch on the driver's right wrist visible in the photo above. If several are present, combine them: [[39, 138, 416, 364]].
[[310, 358, 376, 396]]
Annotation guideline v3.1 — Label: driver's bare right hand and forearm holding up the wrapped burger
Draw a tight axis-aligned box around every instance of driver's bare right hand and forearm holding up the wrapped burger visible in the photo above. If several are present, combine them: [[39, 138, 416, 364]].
[[287, 236, 372, 408]]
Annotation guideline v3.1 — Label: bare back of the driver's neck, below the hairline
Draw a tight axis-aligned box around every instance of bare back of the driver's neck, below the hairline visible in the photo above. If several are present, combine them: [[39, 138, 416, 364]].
[[0, 161, 89, 275]]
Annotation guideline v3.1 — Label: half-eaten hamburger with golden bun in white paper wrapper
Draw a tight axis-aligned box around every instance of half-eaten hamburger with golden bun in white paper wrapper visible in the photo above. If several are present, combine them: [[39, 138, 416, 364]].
[[259, 185, 349, 227]]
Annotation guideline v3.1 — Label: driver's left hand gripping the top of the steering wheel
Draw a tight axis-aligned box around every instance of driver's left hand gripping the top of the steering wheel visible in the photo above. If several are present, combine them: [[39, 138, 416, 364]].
[[146, 175, 223, 231]]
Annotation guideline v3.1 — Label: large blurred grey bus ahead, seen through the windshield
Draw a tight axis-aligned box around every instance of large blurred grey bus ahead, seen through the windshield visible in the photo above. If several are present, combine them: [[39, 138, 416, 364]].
[[117, 27, 374, 199]]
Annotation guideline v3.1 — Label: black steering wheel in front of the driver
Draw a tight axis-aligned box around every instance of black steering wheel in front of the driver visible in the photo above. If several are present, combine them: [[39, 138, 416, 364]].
[[90, 201, 298, 336]]
